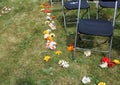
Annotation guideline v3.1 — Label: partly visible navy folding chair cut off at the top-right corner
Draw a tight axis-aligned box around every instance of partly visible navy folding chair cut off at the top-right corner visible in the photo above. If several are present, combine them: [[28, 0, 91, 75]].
[[96, 0, 120, 19]]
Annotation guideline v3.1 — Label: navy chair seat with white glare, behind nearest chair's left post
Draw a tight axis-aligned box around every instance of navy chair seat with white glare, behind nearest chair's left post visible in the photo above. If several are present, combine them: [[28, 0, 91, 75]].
[[64, 0, 90, 10]]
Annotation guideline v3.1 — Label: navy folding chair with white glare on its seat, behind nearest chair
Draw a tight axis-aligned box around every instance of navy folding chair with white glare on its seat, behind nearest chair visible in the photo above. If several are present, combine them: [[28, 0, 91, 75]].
[[62, 0, 90, 31]]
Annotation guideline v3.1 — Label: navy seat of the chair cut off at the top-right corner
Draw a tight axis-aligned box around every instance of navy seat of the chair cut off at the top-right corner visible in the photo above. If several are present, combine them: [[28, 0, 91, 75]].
[[99, 0, 120, 8]]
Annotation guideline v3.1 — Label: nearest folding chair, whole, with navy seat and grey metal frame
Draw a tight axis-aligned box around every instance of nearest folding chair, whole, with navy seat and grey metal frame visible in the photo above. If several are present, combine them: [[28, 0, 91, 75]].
[[72, 0, 118, 59]]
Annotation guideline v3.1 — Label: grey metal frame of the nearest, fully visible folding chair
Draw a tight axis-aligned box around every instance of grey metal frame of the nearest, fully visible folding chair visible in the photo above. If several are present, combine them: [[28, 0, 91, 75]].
[[72, 0, 118, 60]]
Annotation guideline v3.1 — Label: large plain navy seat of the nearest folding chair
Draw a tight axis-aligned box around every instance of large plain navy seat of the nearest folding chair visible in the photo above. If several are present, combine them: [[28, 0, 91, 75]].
[[78, 19, 114, 37]]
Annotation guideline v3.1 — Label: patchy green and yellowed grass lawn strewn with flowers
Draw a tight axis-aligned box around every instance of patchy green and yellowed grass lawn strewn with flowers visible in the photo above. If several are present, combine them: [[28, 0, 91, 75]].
[[0, 0, 120, 85]]
